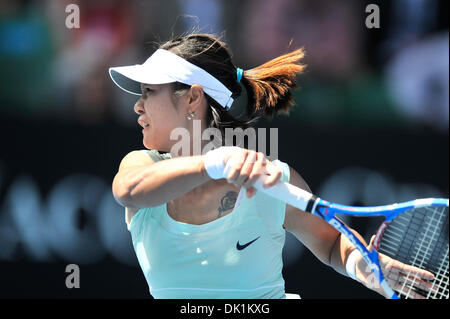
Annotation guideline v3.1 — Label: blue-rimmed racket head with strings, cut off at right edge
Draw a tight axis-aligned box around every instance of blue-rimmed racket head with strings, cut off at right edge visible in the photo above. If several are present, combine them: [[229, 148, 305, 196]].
[[373, 199, 449, 299]]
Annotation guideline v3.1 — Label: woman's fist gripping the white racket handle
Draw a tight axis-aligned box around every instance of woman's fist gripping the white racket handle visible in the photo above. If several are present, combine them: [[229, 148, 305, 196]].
[[224, 148, 282, 198]]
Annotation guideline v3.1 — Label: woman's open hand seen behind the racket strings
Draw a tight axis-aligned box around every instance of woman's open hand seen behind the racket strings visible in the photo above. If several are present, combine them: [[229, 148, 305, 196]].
[[355, 236, 434, 299]]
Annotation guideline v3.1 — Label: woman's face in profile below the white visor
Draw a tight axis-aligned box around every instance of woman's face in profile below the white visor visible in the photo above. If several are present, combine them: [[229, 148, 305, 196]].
[[134, 84, 189, 152]]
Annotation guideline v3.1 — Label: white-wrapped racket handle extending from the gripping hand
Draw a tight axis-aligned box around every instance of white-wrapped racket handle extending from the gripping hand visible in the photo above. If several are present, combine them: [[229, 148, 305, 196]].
[[253, 175, 313, 211]]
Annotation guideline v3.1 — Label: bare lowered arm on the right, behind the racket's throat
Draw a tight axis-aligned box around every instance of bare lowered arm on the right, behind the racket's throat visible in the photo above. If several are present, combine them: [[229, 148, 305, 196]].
[[284, 168, 365, 275]]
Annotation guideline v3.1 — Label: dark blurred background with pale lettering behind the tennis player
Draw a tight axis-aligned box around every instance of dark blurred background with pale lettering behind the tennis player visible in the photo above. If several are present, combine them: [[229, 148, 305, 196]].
[[0, 0, 449, 298]]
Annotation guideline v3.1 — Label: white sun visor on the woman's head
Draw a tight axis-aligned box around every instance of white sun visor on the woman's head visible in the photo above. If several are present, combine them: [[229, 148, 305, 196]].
[[109, 49, 233, 109]]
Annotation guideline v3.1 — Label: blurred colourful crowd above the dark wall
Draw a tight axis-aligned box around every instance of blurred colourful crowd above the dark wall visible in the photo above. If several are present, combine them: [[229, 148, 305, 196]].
[[0, 0, 449, 132]]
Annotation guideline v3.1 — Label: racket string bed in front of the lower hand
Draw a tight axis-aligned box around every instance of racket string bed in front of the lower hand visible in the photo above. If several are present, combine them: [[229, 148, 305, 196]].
[[379, 207, 449, 298]]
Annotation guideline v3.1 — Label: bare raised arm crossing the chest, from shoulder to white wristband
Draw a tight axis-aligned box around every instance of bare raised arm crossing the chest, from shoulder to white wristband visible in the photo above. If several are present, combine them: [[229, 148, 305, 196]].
[[112, 151, 210, 210]]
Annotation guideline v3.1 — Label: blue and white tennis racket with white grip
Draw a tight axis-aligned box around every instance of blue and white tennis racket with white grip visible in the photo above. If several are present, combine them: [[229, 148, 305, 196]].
[[254, 176, 449, 299]]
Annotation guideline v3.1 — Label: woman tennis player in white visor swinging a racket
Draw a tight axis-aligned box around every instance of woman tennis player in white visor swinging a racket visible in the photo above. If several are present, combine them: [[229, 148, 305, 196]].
[[109, 34, 432, 299]]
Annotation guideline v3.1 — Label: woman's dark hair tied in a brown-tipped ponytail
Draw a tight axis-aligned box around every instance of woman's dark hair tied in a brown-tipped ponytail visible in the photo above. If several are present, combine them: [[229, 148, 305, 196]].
[[160, 33, 305, 140]]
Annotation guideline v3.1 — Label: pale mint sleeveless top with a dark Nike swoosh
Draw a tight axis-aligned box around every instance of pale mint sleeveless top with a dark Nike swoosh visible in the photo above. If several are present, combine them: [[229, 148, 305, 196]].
[[128, 150, 290, 299]]
